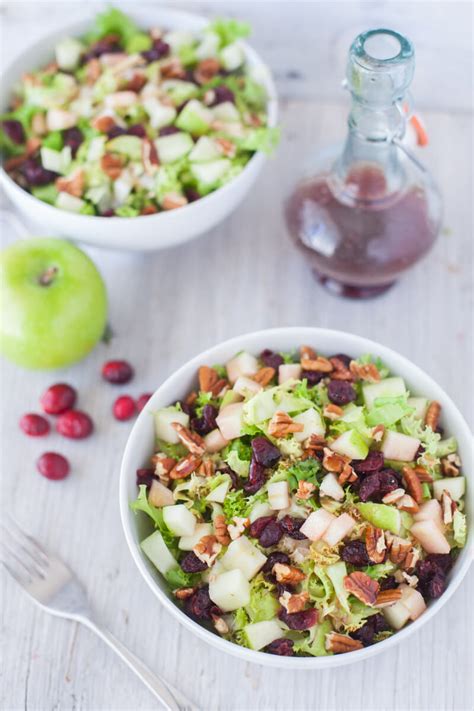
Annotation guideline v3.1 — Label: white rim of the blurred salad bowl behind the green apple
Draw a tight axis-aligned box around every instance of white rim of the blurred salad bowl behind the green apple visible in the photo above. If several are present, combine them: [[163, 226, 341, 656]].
[[0, 7, 278, 226]]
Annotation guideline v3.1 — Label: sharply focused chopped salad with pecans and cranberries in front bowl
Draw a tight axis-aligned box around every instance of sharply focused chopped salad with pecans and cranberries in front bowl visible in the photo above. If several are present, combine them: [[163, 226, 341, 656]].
[[131, 346, 467, 656]]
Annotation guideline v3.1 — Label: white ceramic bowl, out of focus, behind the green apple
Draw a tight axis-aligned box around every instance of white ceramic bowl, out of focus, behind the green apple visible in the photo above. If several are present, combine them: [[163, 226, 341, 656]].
[[0, 7, 277, 252]]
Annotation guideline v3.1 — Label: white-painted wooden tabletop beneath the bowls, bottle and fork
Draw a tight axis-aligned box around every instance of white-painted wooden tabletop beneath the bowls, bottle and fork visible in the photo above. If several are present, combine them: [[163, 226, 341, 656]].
[[0, 3, 474, 711]]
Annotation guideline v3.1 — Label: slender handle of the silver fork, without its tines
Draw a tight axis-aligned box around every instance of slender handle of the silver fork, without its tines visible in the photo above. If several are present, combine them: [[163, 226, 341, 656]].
[[80, 618, 194, 711]]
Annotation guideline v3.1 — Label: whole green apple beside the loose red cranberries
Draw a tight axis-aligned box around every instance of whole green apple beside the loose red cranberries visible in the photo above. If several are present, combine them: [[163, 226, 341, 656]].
[[0, 237, 107, 368]]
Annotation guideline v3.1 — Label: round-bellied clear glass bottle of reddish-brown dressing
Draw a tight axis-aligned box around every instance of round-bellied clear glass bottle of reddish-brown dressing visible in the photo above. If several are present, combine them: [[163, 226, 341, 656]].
[[285, 29, 442, 298]]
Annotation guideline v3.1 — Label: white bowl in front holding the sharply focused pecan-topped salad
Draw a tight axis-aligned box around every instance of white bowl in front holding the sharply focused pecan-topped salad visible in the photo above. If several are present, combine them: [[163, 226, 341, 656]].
[[120, 328, 473, 669]]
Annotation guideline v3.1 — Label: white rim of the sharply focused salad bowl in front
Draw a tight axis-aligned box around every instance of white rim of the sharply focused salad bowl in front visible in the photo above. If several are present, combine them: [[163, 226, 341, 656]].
[[119, 326, 473, 669]]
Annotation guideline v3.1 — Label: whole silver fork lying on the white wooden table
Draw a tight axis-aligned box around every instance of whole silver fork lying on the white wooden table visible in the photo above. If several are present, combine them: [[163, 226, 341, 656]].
[[0, 516, 198, 711]]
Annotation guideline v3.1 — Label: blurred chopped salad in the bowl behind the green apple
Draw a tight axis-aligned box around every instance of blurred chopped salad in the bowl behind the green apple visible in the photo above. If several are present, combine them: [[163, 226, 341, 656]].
[[0, 8, 278, 217]]
